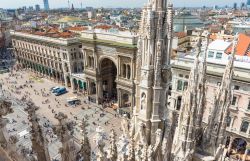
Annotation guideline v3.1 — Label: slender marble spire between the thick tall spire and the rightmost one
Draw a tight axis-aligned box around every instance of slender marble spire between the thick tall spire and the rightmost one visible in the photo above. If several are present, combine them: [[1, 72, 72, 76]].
[[174, 33, 209, 161]]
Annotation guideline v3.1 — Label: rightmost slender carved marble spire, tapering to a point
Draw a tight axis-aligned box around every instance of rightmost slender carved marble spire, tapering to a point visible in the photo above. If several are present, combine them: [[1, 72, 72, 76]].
[[203, 34, 238, 156]]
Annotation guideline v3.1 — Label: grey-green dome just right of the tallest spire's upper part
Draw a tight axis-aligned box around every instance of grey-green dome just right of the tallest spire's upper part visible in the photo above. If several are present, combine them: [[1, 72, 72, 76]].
[[174, 13, 204, 32]]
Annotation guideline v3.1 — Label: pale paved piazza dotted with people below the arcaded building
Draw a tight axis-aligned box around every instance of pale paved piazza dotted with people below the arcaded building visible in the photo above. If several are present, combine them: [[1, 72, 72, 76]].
[[0, 71, 121, 159]]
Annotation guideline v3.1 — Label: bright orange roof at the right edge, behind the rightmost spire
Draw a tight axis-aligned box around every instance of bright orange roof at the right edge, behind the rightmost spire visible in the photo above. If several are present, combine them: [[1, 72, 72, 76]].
[[226, 34, 250, 56]]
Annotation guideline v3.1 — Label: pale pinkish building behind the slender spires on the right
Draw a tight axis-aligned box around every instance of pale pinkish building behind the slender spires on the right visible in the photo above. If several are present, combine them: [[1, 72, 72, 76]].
[[169, 36, 250, 158]]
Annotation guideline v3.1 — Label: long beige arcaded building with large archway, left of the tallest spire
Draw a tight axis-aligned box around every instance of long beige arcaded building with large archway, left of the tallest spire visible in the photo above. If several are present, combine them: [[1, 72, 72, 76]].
[[11, 27, 137, 113]]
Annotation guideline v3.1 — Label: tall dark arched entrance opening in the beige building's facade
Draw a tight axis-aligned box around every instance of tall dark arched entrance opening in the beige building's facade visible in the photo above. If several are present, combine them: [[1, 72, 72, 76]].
[[99, 58, 117, 102]]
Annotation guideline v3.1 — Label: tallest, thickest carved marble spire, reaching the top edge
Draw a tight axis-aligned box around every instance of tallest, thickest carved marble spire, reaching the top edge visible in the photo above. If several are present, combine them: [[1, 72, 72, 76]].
[[135, 0, 173, 145]]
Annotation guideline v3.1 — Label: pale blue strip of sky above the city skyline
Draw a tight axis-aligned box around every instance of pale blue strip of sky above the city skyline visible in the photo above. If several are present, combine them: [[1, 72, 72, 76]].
[[0, 0, 247, 8]]
